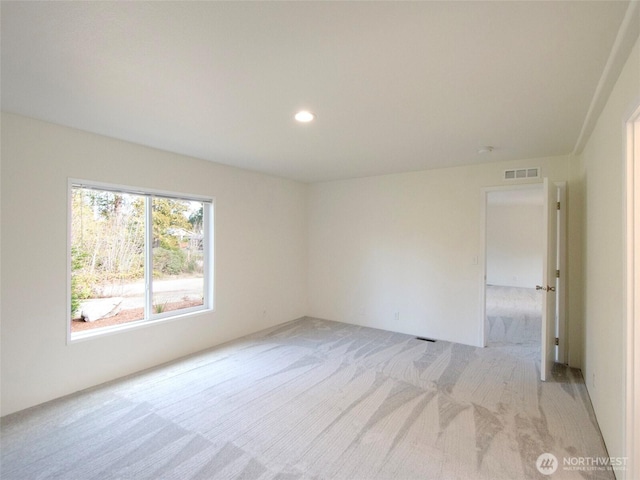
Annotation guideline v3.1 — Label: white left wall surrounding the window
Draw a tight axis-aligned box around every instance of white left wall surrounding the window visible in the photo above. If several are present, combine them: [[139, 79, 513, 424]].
[[0, 114, 307, 415]]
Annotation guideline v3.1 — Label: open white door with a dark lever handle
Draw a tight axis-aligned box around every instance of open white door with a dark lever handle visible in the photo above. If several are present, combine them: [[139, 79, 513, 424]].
[[536, 178, 558, 382]]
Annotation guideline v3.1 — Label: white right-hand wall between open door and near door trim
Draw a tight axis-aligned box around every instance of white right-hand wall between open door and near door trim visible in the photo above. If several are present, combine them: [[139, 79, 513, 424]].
[[574, 35, 640, 470]]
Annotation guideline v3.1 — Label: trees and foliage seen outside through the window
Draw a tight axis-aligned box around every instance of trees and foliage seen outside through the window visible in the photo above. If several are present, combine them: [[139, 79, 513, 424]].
[[71, 187, 203, 315]]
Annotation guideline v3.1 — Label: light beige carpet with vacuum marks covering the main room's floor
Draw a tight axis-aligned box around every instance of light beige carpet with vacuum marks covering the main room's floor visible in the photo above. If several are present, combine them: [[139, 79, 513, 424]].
[[1, 304, 613, 480]]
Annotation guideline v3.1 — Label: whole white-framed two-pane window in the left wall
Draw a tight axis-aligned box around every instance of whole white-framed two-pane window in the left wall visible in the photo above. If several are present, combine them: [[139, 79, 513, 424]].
[[69, 181, 213, 339]]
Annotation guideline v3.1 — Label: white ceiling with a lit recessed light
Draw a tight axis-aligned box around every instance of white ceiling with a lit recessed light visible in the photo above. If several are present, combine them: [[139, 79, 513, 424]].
[[0, 1, 639, 182]]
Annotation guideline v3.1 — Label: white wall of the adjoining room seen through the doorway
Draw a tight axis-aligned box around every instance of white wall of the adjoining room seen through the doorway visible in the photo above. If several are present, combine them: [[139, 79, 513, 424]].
[[487, 201, 544, 288]]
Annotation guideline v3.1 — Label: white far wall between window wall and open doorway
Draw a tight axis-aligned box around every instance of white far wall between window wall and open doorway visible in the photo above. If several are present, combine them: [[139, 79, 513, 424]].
[[309, 157, 568, 345]]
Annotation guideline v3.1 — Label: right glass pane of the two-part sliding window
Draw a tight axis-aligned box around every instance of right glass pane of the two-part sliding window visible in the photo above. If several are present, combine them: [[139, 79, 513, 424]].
[[151, 197, 204, 314]]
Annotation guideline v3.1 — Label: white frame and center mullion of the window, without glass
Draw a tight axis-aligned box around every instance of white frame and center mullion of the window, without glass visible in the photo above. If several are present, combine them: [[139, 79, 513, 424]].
[[67, 178, 215, 343]]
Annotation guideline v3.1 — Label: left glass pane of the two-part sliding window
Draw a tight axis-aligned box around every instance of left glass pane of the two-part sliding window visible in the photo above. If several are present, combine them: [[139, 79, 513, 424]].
[[71, 187, 145, 332]]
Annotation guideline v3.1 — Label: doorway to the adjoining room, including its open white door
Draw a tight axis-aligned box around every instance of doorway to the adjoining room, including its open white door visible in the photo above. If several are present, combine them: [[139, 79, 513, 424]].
[[480, 179, 568, 380]]
